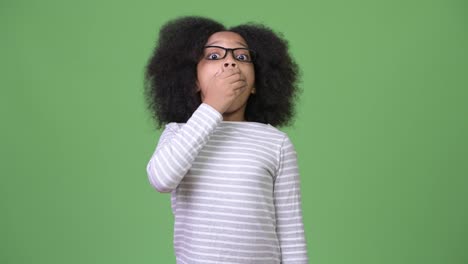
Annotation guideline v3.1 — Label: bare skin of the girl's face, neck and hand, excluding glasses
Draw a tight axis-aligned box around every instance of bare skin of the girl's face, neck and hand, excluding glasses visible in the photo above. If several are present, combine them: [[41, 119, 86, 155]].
[[197, 31, 255, 121]]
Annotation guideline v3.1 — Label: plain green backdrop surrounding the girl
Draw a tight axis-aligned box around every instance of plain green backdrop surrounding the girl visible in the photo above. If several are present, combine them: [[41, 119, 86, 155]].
[[0, 0, 468, 264]]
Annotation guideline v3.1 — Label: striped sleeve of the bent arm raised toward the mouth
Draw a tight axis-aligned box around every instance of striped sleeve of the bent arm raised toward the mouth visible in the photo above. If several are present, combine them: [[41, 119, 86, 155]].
[[146, 103, 223, 192]]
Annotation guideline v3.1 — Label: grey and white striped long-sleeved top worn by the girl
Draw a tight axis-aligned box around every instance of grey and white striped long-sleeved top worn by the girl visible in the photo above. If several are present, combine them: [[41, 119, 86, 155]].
[[146, 103, 308, 264]]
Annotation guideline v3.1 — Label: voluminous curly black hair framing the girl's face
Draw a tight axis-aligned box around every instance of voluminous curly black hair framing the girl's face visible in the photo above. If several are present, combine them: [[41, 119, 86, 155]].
[[144, 16, 299, 128]]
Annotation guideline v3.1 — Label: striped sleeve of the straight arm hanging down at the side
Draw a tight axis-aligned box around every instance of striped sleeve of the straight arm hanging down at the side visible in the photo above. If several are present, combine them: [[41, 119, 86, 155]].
[[274, 136, 308, 264]]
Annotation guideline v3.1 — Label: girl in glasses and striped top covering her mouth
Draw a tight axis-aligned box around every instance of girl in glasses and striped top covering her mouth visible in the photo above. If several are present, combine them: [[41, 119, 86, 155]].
[[145, 17, 308, 264]]
